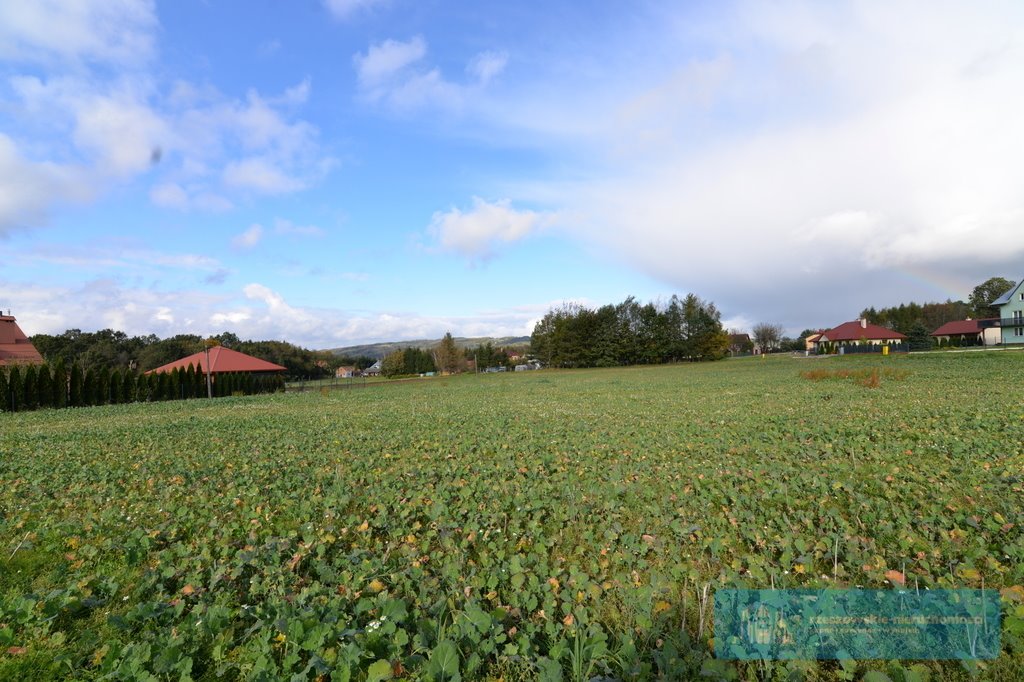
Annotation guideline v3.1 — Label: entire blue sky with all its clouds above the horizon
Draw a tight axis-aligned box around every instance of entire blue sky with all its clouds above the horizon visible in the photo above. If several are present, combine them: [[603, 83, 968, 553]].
[[0, 0, 1024, 347]]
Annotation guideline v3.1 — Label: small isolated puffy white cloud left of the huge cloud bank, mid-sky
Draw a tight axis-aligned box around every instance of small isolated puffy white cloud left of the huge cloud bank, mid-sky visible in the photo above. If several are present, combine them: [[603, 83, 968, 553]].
[[427, 197, 554, 258]]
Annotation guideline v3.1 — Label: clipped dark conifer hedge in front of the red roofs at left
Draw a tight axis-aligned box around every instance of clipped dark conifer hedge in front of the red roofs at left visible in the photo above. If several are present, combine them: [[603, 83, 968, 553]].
[[0, 359, 285, 412]]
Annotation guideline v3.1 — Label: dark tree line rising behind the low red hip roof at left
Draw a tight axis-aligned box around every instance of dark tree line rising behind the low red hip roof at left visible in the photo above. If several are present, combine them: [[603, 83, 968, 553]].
[[30, 329, 342, 378]]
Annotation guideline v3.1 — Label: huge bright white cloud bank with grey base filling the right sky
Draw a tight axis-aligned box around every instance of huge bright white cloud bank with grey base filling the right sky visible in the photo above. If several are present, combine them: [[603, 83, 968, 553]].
[[477, 0, 1024, 326]]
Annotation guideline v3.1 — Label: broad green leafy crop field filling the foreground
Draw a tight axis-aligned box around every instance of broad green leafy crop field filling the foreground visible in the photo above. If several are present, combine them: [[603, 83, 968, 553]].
[[0, 352, 1024, 681]]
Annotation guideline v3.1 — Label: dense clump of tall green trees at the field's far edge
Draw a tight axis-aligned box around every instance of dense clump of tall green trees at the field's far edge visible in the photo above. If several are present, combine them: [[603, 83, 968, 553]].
[[530, 294, 729, 368]]
